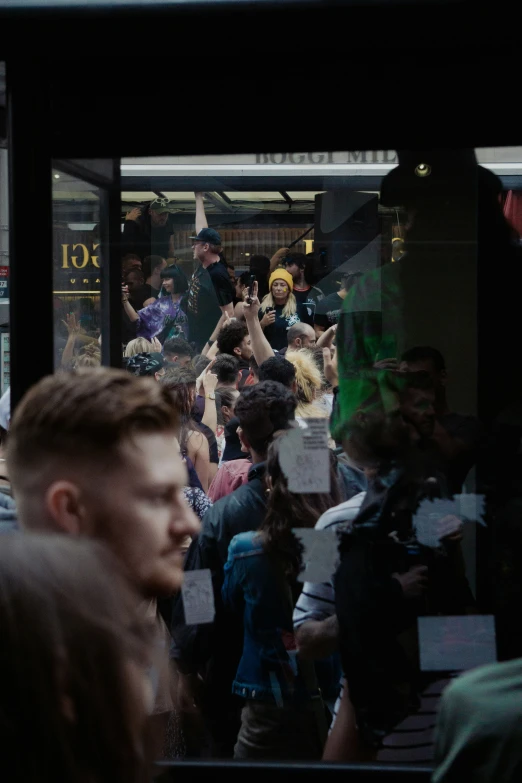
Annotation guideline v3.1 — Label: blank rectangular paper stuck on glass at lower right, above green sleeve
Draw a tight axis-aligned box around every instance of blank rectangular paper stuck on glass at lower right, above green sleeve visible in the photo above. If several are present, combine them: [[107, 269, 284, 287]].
[[418, 614, 497, 672]]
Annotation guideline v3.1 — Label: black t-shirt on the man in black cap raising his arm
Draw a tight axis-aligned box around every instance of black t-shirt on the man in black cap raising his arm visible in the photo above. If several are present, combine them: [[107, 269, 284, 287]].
[[187, 261, 234, 348]]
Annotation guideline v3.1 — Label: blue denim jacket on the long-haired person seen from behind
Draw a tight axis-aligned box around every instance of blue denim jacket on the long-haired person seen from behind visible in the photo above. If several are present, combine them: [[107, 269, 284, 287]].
[[222, 532, 315, 707]]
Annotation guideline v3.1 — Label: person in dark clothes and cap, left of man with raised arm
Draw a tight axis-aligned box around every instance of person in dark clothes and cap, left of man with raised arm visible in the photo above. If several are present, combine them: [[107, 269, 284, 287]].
[[123, 197, 174, 260]]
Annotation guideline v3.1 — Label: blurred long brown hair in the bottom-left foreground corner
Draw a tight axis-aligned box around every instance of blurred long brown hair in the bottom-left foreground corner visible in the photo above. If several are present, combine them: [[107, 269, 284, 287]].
[[0, 533, 152, 783]]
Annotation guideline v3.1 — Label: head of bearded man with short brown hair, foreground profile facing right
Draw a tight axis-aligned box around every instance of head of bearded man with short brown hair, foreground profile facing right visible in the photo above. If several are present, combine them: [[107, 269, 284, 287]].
[[7, 368, 199, 598]]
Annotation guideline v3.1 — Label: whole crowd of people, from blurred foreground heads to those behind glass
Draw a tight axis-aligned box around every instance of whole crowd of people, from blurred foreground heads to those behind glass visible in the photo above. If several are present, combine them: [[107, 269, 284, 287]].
[[0, 161, 520, 783]]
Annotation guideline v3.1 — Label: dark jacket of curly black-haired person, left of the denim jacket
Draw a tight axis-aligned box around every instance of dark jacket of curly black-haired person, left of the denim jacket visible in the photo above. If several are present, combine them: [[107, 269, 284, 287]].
[[171, 463, 266, 688]]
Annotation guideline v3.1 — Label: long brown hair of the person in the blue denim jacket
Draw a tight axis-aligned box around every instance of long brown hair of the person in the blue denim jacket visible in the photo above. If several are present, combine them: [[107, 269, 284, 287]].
[[259, 430, 341, 580]]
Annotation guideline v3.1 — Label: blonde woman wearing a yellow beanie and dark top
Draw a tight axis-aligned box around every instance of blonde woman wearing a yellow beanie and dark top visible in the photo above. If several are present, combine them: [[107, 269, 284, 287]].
[[260, 268, 313, 351]]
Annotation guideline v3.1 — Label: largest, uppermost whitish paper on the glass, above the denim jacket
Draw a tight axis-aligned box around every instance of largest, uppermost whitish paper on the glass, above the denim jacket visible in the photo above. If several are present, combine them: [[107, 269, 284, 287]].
[[279, 419, 330, 494]]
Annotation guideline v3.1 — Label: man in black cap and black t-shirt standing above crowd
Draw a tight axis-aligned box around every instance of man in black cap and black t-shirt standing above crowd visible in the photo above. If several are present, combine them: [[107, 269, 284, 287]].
[[187, 201, 234, 350]]
